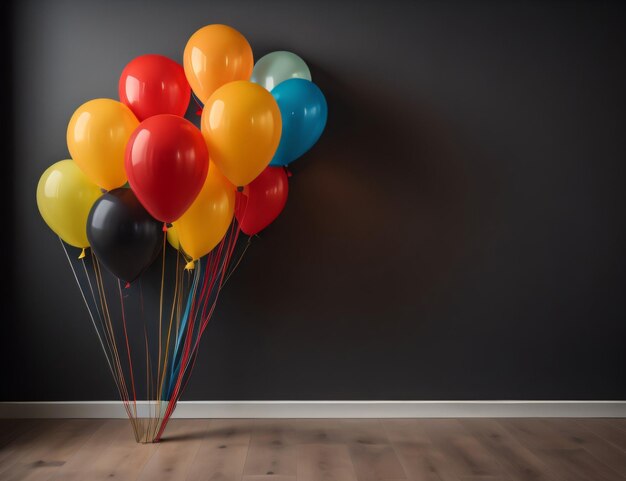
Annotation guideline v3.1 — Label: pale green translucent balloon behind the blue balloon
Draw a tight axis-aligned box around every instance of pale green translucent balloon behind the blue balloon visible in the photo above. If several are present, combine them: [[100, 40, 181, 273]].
[[250, 50, 311, 92]]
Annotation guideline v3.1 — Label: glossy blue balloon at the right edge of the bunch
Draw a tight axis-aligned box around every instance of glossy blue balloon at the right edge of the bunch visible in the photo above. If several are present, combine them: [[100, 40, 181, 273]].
[[270, 78, 328, 166]]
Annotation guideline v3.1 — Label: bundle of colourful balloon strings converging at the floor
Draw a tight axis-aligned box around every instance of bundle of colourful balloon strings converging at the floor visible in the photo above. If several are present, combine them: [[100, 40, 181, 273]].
[[62, 221, 241, 441]]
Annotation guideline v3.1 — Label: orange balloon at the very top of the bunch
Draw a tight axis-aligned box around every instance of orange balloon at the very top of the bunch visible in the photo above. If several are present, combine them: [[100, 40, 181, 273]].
[[183, 24, 254, 103]]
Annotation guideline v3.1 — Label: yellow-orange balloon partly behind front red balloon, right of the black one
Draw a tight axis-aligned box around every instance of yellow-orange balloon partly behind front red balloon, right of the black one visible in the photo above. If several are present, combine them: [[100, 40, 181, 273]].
[[174, 164, 235, 260]]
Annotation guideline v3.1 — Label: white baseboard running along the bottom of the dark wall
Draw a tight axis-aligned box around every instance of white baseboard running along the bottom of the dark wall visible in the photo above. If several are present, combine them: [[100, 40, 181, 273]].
[[0, 401, 626, 418]]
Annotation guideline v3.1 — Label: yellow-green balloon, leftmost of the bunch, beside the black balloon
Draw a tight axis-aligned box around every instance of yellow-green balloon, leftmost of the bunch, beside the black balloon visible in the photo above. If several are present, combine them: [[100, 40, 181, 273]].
[[37, 160, 101, 248]]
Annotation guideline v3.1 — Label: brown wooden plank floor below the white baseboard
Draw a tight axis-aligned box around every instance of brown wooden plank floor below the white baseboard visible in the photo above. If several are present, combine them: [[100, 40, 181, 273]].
[[0, 419, 626, 481]]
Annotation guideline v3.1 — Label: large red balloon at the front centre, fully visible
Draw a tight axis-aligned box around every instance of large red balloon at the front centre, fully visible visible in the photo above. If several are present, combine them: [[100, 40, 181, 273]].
[[125, 114, 209, 222]]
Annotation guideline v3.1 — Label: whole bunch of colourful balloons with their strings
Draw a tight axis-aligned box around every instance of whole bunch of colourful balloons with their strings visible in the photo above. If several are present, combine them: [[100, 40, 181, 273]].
[[37, 25, 327, 442]]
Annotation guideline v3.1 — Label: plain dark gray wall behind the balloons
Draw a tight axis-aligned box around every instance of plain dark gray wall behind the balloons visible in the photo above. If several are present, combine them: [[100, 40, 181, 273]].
[[2, 0, 626, 400]]
